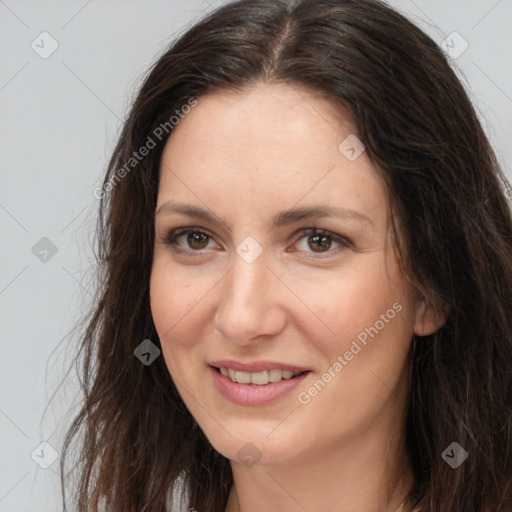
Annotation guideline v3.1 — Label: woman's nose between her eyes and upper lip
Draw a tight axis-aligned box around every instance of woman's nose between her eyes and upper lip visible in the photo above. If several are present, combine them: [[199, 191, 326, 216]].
[[214, 252, 286, 345]]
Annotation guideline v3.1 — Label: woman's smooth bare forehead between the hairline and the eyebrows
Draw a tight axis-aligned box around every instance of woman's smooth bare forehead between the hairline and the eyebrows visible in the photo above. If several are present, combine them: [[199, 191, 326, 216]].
[[158, 84, 387, 230]]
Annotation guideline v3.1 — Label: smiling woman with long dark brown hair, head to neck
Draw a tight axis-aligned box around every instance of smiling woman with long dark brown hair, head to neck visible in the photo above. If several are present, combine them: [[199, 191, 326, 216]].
[[61, 0, 512, 512]]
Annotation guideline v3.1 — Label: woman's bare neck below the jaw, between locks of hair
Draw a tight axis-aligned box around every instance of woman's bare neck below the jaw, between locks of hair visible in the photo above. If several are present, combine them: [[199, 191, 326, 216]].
[[225, 400, 413, 512]]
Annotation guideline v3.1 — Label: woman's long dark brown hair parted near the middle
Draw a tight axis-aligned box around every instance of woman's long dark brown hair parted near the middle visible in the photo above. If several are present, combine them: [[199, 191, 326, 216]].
[[61, 0, 512, 512]]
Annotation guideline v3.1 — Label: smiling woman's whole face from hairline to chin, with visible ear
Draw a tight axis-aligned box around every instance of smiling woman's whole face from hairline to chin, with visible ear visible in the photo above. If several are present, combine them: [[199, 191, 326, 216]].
[[150, 84, 437, 465]]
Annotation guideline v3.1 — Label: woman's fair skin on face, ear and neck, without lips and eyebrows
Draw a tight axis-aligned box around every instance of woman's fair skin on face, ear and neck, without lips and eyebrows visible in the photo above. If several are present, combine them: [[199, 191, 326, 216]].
[[150, 83, 444, 512]]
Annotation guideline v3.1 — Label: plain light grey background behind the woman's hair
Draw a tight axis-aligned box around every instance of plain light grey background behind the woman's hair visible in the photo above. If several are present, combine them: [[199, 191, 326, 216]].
[[0, 0, 512, 512]]
